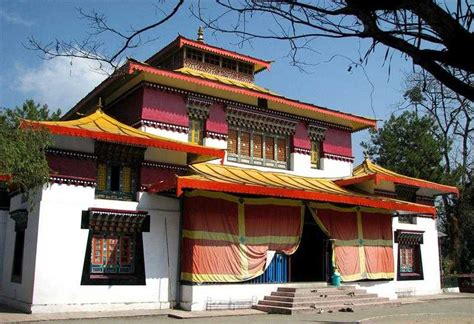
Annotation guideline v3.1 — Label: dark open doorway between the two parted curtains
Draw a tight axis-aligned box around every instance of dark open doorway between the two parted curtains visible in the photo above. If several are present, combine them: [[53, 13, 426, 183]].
[[289, 210, 332, 282]]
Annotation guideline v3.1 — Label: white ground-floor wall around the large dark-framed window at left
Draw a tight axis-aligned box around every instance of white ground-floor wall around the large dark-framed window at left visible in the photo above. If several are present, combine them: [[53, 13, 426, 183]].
[[26, 184, 179, 313]]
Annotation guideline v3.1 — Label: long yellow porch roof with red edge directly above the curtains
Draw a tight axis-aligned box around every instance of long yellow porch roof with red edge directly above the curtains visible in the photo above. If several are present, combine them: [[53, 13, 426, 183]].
[[149, 163, 436, 216]]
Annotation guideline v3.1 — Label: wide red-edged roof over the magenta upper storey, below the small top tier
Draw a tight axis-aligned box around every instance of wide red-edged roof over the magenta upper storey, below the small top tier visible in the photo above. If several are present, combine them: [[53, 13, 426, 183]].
[[63, 60, 376, 131]]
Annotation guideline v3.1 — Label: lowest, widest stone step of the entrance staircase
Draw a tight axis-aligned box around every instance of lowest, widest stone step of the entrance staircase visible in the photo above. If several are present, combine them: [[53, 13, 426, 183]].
[[254, 301, 401, 314]]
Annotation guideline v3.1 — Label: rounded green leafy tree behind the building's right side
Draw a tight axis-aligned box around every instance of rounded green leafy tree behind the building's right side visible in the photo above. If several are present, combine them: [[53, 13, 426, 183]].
[[361, 111, 446, 182]]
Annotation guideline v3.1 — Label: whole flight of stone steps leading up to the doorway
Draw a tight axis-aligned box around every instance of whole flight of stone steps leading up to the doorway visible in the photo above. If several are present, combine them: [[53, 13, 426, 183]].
[[254, 286, 400, 314]]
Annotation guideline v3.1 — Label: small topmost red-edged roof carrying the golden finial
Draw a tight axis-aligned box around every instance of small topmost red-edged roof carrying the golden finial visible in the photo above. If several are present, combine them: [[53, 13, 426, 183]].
[[145, 35, 271, 73]]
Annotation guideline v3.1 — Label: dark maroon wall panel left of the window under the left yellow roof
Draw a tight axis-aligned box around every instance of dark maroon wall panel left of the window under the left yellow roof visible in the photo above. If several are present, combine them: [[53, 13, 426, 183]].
[[46, 154, 97, 180]]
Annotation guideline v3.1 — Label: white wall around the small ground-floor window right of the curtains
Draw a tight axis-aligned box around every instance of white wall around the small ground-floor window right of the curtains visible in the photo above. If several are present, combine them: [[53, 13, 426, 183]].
[[347, 217, 441, 299]]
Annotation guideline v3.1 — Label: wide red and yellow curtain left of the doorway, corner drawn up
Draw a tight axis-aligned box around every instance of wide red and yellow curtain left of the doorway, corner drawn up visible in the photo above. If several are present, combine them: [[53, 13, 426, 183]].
[[181, 191, 304, 282]]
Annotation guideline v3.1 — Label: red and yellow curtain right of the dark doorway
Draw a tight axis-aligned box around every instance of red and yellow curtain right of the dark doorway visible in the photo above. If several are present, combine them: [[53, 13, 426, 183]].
[[310, 203, 394, 281]]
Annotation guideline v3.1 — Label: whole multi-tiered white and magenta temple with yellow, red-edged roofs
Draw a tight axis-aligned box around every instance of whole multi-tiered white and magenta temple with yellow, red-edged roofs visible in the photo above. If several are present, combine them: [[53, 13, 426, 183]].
[[0, 36, 457, 312]]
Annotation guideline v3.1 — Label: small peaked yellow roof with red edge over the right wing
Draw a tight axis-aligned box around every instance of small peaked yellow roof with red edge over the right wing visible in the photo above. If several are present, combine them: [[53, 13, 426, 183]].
[[334, 158, 459, 195]]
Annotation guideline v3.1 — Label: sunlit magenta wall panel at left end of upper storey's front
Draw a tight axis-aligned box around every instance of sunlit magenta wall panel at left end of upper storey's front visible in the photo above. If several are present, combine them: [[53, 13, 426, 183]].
[[141, 88, 188, 127]]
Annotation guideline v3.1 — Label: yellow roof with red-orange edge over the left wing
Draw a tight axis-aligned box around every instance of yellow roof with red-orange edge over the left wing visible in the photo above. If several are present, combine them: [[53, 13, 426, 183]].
[[20, 109, 225, 162]]
